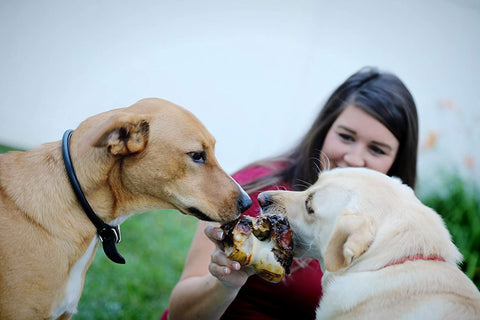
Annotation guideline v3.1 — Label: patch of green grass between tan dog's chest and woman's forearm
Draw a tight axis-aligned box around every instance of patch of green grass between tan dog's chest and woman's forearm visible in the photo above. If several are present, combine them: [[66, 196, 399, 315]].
[[74, 210, 197, 320]]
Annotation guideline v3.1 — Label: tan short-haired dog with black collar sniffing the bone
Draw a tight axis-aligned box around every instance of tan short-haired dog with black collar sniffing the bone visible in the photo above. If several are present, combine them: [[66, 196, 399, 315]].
[[0, 99, 251, 319]]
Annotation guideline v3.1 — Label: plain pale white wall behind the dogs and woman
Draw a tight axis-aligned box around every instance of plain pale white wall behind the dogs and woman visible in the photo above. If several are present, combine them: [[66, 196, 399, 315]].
[[0, 0, 480, 192]]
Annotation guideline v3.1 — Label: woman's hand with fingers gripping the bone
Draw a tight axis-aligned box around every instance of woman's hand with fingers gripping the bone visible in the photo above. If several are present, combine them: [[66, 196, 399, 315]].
[[204, 225, 254, 289]]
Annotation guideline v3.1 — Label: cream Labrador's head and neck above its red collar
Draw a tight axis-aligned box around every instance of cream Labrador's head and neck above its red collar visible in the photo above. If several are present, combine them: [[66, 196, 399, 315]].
[[258, 168, 461, 272]]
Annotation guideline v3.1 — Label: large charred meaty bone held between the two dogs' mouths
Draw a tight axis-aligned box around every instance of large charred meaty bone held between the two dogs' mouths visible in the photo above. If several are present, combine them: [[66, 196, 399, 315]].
[[222, 214, 293, 282]]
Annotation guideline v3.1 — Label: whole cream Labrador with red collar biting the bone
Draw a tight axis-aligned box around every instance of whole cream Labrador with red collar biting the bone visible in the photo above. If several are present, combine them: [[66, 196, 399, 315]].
[[258, 168, 480, 320]]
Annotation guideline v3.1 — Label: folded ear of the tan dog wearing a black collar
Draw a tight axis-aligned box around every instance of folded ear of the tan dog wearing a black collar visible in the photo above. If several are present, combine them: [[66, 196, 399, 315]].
[[90, 113, 150, 156]]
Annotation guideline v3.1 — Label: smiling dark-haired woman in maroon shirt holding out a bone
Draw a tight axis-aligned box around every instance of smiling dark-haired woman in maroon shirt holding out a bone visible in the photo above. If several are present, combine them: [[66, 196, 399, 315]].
[[164, 68, 418, 320]]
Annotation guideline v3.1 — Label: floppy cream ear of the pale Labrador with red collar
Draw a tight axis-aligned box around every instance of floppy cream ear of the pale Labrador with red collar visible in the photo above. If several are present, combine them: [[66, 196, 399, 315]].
[[324, 210, 375, 272]]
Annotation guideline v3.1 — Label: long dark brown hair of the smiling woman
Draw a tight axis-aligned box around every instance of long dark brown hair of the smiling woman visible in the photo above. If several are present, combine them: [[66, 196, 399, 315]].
[[243, 68, 418, 192]]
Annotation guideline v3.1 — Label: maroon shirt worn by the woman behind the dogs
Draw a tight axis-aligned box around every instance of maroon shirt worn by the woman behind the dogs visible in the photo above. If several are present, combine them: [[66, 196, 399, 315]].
[[221, 166, 322, 320]]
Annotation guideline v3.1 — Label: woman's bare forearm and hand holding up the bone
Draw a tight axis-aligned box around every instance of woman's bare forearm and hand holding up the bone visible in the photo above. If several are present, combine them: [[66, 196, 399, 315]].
[[168, 221, 253, 320]]
